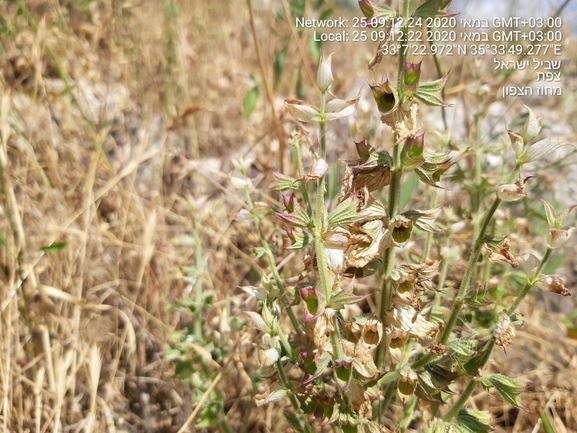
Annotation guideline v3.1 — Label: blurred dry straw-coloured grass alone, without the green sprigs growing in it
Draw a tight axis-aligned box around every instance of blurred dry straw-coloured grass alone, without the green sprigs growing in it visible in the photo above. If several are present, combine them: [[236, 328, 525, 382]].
[[0, 0, 577, 433]]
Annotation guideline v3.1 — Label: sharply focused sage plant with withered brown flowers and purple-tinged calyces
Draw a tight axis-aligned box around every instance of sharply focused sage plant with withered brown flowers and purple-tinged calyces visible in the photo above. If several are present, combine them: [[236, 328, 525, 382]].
[[236, 0, 574, 433]]
